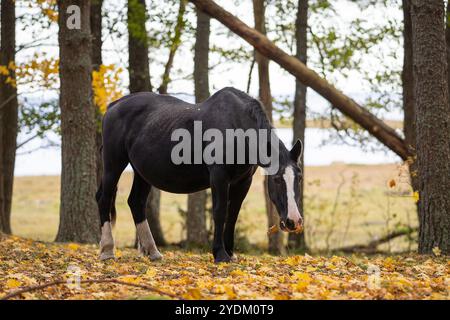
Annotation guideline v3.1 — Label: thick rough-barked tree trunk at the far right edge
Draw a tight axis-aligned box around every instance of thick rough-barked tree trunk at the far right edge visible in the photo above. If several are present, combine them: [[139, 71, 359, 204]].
[[411, 0, 450, 254]]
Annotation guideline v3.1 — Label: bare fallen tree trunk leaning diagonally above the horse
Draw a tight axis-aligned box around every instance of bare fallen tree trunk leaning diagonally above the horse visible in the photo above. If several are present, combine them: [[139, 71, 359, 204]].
[[190, 0, 409, 160]]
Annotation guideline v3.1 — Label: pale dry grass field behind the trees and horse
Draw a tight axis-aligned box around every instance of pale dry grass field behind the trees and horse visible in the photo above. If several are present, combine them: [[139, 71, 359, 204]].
[[12, 163, 417, 251]]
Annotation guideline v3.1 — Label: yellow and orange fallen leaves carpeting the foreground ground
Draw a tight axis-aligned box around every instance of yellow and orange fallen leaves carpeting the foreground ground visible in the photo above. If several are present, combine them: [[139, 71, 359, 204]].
[[0, 236, 450, 299]]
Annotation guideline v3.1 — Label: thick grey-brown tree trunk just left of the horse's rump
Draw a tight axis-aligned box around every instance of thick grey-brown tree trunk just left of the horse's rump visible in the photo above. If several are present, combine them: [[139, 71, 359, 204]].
[[56, 0, 100, 243]]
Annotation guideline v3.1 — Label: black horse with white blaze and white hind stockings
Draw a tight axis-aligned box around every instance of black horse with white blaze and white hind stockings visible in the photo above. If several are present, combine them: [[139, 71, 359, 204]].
[[97, 88, 302, 262]]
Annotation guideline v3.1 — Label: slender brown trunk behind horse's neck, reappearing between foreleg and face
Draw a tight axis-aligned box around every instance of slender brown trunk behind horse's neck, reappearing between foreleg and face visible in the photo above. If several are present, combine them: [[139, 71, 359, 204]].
[[253, 0, 284, 254]]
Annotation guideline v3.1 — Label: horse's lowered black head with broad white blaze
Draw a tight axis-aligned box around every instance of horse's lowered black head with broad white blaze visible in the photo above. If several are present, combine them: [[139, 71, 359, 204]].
[[268, 140, 303, 232]]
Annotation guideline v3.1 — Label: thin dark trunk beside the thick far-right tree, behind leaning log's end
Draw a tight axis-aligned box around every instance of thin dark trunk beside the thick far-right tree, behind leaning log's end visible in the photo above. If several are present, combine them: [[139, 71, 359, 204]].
[[402, 0, 419, 200]]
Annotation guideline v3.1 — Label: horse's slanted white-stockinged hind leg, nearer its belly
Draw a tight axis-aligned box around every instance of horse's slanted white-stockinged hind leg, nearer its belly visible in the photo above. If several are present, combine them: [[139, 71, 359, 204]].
[[128, 171, 162, 260]]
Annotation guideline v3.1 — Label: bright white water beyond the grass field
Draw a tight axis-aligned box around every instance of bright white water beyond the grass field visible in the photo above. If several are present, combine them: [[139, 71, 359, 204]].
[[15, 128, 400, 176]]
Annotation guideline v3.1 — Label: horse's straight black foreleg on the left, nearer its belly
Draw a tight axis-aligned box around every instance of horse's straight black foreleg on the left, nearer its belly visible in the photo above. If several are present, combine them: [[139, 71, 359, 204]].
[[210, 168, 231, 263]]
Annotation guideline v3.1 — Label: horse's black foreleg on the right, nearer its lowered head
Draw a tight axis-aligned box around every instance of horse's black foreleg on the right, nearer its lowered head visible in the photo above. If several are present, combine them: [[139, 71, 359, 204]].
[[224, 176, 252, 260]]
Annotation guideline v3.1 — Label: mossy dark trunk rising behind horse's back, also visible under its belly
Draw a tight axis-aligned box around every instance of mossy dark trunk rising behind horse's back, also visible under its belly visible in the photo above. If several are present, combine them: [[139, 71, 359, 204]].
[[127, 0, 166, 246]]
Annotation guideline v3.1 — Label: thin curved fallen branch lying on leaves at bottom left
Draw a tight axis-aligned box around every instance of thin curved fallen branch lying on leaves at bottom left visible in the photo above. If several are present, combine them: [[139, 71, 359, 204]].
[[0, 279, 183, 300]]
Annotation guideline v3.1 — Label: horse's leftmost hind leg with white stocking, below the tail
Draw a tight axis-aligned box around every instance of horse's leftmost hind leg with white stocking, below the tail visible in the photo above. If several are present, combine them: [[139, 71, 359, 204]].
[[96, 161, 127, 260]]
